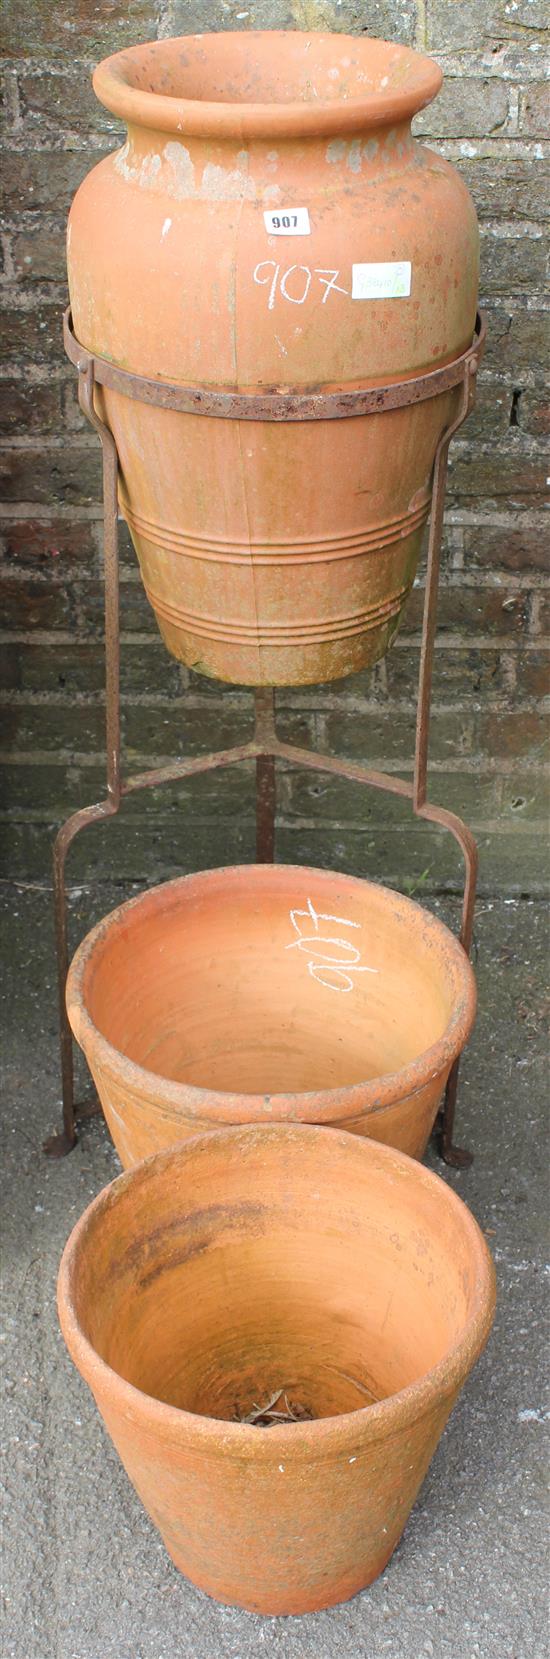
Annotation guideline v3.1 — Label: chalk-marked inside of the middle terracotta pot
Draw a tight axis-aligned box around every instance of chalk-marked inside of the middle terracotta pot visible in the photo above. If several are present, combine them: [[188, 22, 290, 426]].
[[81, 866, 470, 1097]]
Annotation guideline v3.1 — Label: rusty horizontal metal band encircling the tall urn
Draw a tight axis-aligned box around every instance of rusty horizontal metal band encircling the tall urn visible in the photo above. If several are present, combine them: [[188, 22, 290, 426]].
[[63, 309, 487, 421]]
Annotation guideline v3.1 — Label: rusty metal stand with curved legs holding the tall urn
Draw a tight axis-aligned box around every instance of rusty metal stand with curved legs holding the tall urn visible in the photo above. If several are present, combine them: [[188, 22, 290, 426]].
[[45, 312, 485, 1168]]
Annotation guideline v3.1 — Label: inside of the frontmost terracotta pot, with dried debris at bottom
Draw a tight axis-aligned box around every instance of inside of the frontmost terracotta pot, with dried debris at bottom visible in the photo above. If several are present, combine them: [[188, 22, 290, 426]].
[[71, 1126, 487, 1433]]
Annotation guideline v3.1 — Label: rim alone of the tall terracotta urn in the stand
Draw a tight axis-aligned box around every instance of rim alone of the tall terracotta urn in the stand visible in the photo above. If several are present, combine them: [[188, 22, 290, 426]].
[[93, 30, 442, 143]]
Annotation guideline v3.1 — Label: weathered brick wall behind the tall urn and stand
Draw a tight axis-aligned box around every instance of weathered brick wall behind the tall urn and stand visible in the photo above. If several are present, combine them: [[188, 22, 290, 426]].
[[2, 0, 550, 893]]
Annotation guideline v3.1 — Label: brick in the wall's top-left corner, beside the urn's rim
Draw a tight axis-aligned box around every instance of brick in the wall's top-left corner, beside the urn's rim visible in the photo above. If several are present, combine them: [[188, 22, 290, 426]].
[[3, 0, 157, 58]]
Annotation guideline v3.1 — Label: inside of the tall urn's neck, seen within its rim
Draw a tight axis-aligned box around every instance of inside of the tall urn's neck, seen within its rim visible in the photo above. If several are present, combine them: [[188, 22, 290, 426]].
[[111, 30, 432, 105]]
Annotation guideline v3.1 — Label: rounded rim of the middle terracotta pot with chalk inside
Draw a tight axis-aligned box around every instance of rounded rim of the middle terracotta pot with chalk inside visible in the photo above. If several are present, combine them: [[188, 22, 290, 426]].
[[66, 864, 477, 1128]]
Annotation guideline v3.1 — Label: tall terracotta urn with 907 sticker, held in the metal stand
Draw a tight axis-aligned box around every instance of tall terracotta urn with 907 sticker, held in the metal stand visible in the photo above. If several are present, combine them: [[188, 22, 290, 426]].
[[68, 32, 477, 685]]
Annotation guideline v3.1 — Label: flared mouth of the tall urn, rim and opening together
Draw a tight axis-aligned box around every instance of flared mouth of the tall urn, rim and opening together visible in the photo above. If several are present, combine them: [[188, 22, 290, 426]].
[[93, 30, 442, 139]]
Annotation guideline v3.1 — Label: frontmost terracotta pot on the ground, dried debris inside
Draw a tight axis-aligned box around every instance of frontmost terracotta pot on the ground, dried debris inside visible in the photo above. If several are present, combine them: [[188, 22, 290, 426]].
[[58, 1125, 495, 1614]]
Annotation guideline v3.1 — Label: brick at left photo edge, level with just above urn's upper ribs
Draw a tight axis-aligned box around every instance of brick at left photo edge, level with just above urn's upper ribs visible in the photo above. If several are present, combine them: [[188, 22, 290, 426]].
[[0, 445, 101, 506]]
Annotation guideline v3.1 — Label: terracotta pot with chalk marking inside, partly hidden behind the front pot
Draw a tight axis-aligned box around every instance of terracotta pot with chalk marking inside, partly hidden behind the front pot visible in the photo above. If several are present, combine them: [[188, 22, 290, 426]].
[[66, 864, 475, 1165]]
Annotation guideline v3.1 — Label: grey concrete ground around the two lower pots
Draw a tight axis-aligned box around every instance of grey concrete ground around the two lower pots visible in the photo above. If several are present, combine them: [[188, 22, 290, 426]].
[[2, 886, 550, 1659]]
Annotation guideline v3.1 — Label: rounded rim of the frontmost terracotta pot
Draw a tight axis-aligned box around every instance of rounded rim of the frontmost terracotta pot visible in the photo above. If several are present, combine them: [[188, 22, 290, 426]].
[[58, 1123, 495, 1463]]
